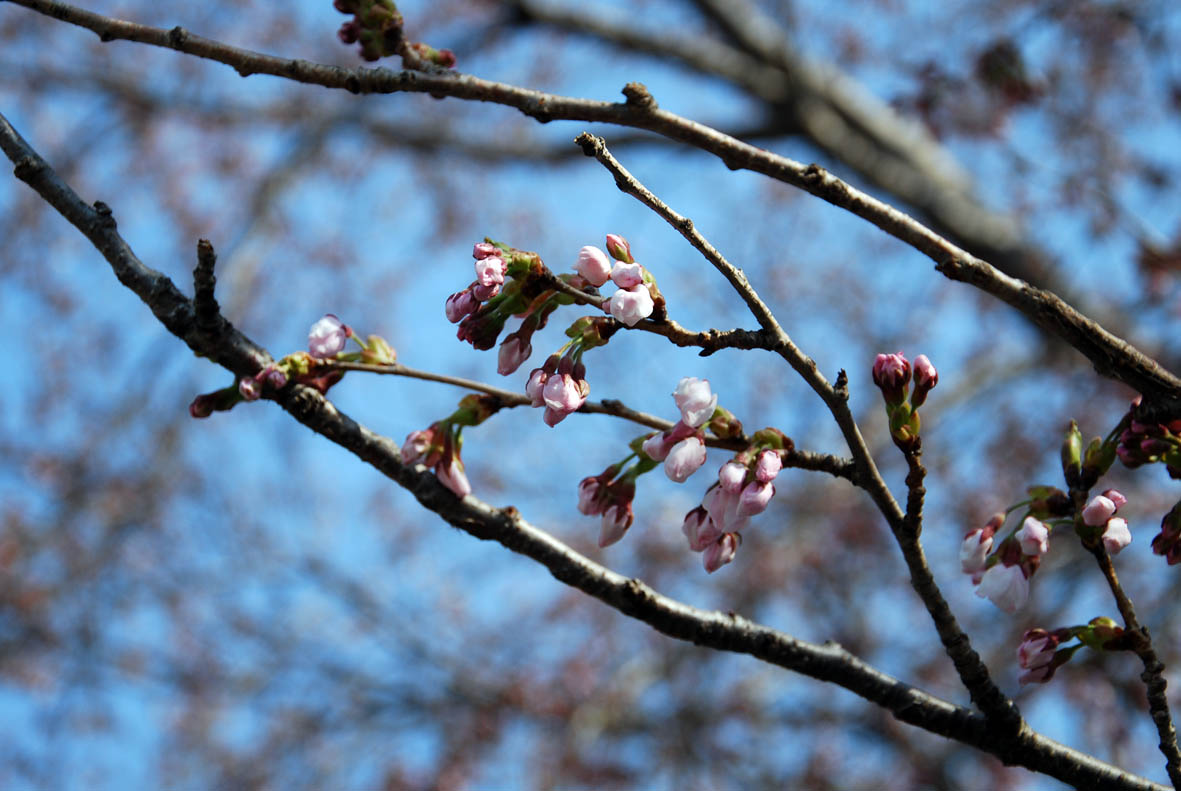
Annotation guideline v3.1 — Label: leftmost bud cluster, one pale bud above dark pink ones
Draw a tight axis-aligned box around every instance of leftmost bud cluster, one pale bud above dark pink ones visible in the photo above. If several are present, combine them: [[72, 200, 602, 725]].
[[189, 313, 398, 418]]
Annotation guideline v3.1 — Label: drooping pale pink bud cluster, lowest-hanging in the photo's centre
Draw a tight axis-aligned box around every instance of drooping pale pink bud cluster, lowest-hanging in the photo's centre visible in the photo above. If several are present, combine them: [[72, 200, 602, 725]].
[[681, 429, 792, 574]]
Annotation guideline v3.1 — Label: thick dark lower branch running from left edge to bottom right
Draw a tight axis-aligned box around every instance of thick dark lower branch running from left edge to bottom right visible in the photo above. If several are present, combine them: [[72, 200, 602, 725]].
[[0, 102, 1164, 791]]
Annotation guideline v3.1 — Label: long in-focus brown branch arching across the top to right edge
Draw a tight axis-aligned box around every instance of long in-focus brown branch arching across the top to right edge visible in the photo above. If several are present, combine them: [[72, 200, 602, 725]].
[[7, 0, 1181, 401]]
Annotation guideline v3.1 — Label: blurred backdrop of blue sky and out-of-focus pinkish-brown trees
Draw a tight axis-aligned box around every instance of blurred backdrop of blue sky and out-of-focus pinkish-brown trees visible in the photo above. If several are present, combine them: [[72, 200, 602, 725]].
[[0, 0, 1181, 789]]
